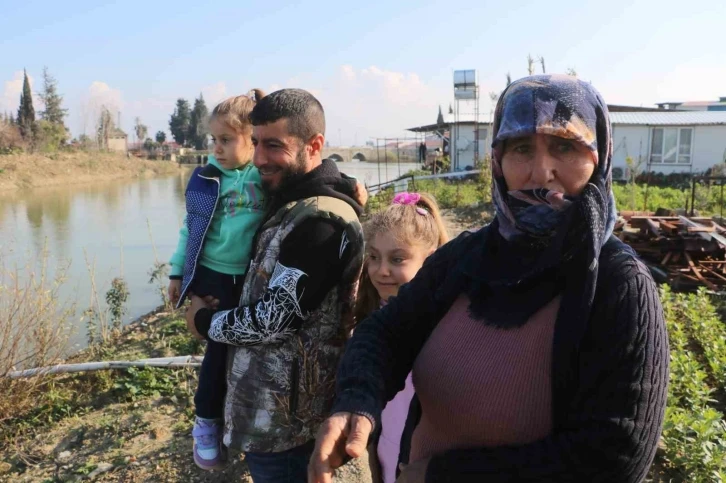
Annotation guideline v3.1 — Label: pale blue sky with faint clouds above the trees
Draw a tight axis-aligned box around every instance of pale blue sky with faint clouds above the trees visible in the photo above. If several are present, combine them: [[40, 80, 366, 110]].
[[0, 0, 726, 144]]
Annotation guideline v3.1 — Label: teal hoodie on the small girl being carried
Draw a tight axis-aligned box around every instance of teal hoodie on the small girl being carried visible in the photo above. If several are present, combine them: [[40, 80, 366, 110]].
[[170, 156, 265, 276]]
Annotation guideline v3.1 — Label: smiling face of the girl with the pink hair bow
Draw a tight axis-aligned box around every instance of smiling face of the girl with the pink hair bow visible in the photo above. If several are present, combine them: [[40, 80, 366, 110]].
[[366, 233, 432, 300]]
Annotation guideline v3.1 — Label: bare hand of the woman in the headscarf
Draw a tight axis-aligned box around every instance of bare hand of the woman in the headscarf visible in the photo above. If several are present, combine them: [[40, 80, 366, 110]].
[[308, 413, 373, 483]]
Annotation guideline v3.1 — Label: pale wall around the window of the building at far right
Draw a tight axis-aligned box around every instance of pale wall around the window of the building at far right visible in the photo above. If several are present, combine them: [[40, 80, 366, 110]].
[[613, 125, 726, 176]]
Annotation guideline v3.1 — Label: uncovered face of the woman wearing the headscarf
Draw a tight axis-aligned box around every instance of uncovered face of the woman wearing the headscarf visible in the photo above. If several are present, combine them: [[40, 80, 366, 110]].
[[502, 134, 597, 196]]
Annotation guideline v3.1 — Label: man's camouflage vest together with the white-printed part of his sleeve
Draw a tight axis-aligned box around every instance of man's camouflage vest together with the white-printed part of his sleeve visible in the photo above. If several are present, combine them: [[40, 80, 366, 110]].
[[208, 196, 363, 452]]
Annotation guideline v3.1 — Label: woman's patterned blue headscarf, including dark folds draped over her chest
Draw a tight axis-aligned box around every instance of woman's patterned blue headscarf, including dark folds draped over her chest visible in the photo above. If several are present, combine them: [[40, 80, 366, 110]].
[[463, 75, 617, 326]]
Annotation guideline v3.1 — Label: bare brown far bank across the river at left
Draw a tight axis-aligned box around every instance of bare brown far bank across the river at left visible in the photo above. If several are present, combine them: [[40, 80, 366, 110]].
[[0, 151, 179, 191]]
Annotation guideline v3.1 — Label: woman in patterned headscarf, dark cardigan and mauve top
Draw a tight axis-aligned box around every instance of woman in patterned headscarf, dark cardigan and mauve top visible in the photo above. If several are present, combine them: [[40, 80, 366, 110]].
[[309, 75, 668, 483]]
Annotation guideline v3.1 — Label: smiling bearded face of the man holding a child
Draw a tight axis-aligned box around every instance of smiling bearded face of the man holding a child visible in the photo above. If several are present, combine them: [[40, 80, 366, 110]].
[[252, 119, 312, 193]]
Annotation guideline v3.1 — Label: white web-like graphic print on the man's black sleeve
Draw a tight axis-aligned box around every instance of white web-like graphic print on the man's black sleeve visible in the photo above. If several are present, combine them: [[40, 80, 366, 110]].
[[209, 262, 307, 345]]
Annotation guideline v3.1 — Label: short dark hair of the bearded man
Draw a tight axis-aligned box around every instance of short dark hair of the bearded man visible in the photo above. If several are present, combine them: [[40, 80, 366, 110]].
[[250, 89, 325, 142]]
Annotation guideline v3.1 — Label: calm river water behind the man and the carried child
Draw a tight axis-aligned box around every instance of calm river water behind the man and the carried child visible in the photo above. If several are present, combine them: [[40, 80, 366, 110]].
[[0, 163, 418, 346]]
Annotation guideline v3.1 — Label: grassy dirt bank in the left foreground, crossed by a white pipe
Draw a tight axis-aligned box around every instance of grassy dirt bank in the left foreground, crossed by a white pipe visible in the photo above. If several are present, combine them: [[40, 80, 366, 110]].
[[0, 312, 247, 482]]
